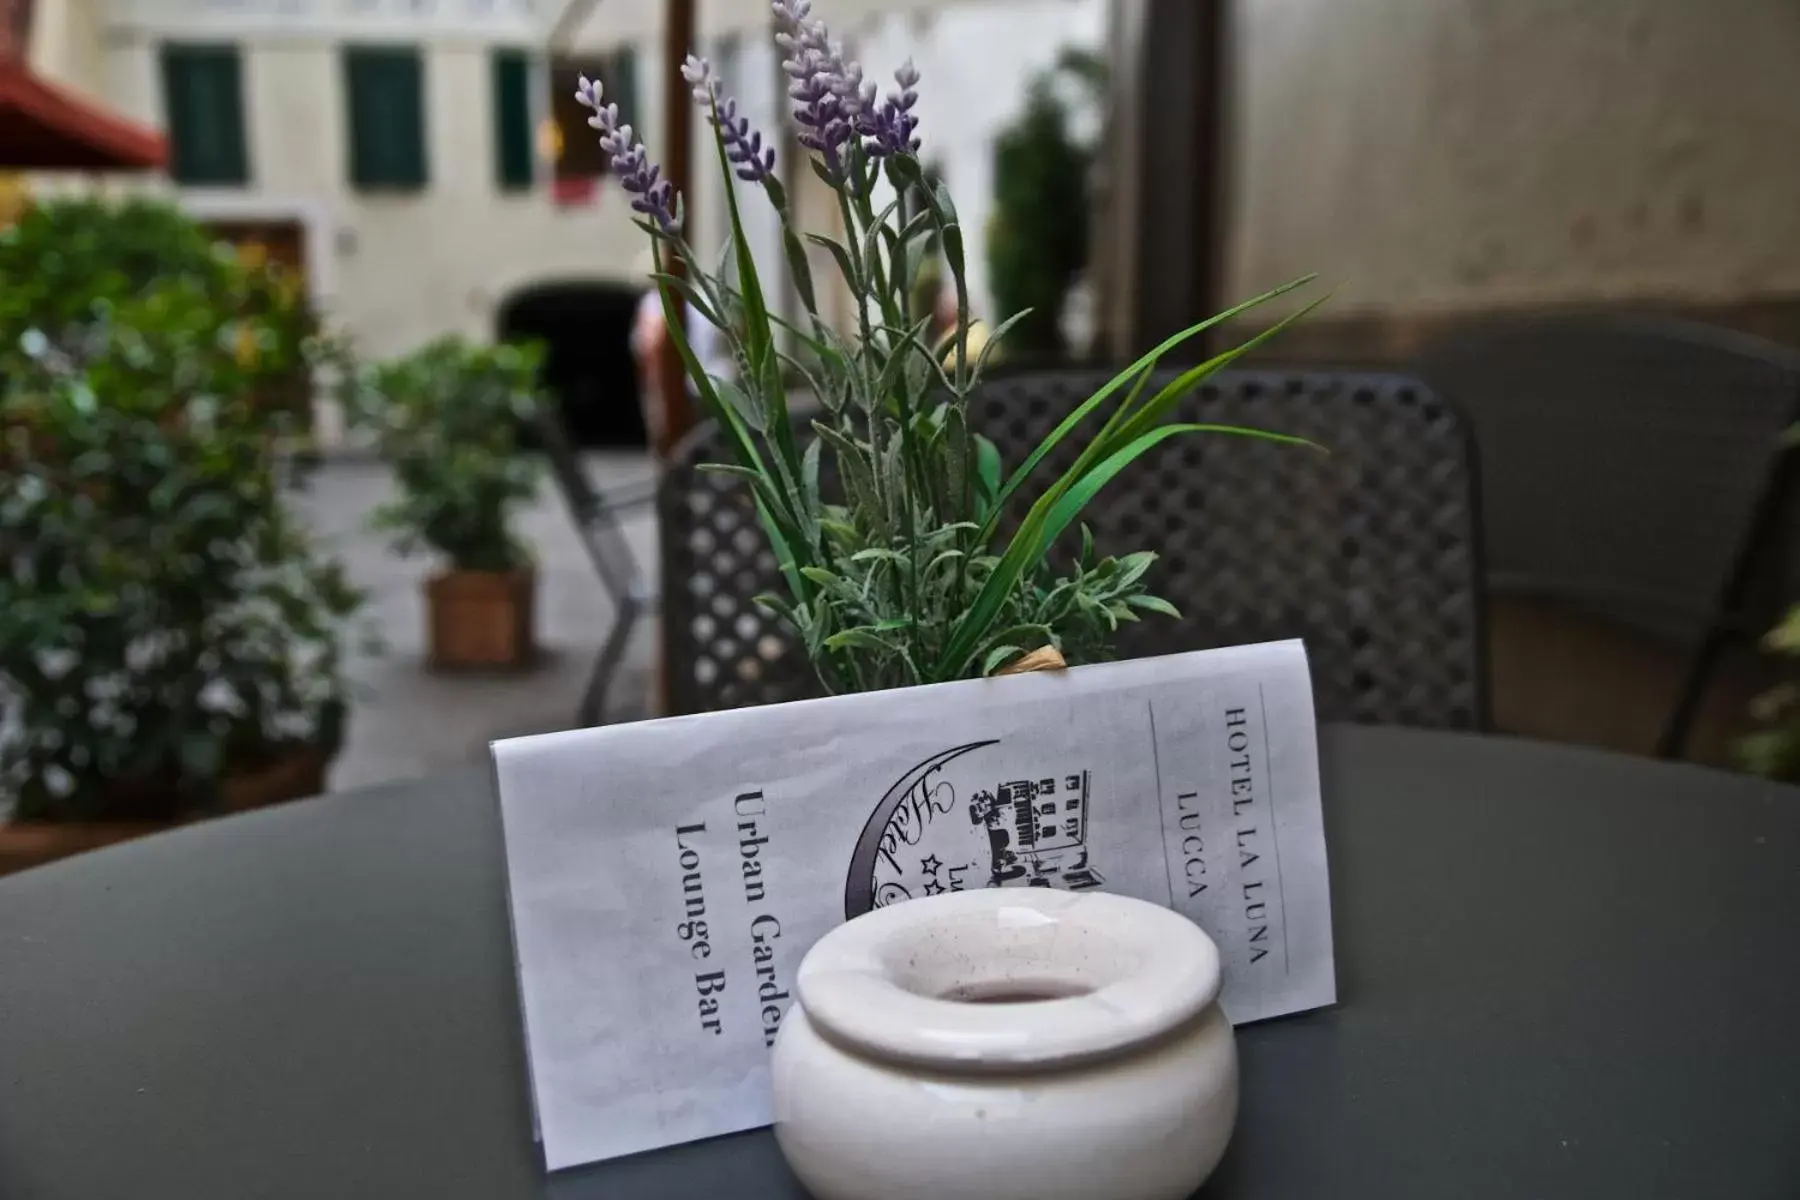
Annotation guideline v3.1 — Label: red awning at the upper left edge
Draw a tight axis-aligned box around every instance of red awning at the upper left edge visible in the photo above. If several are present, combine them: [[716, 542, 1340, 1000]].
[[0, 61, 167, 171]]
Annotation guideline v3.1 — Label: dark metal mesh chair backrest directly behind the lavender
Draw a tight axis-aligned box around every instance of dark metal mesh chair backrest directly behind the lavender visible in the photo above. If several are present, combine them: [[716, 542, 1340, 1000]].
[[659, 371, 1485, 729]]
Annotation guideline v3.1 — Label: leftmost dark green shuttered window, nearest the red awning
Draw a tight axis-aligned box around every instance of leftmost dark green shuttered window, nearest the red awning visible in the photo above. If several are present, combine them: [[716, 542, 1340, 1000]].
[[162, 45, 250, 187]]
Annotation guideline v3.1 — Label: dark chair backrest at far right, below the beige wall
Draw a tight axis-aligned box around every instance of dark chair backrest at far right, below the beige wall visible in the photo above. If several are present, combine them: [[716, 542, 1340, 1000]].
[[1417, 317, 1800, 644]]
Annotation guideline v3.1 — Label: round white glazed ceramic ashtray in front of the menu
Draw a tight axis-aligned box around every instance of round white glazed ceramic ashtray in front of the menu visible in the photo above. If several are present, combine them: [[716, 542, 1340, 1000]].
[[774, 889, 1238, 1200]]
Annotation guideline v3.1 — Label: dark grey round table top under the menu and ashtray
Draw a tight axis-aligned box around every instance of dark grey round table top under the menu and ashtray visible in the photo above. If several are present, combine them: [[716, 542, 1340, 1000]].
[[0, 729, 1800, 1200]]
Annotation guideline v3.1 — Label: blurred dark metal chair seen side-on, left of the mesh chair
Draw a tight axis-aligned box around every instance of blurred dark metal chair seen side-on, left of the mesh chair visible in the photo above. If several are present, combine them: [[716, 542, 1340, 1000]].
[[533, 407, 659, 727]]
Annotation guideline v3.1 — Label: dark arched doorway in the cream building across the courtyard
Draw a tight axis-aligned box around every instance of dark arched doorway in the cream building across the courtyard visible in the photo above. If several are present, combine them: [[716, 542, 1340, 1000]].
[[499, 282, 646, 446]]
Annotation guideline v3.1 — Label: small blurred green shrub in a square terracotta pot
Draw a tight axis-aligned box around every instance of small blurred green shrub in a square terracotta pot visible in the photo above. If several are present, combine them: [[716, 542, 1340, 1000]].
[[355, 336, 540, 669]]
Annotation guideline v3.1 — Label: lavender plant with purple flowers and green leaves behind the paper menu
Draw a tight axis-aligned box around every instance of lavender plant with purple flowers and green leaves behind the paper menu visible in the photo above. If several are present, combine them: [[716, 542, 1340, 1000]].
[[576, 0, 1318, 691]]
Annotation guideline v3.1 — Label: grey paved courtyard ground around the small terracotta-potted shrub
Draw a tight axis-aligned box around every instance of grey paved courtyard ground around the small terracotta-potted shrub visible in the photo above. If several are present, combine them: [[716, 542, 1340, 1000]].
[[288, 453, 655, 790]]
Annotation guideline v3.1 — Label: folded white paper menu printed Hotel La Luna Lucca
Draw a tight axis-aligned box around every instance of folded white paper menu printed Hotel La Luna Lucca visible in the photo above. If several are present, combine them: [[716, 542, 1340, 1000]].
[[493, 642, 1336, 1169]]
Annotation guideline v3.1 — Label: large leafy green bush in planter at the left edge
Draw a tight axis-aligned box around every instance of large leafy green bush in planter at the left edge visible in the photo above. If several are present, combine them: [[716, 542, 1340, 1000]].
[[0, 200, 358, 873]]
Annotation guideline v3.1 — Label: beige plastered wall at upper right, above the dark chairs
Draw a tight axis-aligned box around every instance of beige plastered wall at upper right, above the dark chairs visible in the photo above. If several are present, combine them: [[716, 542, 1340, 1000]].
[[1222, 0, 1800, 340]]
